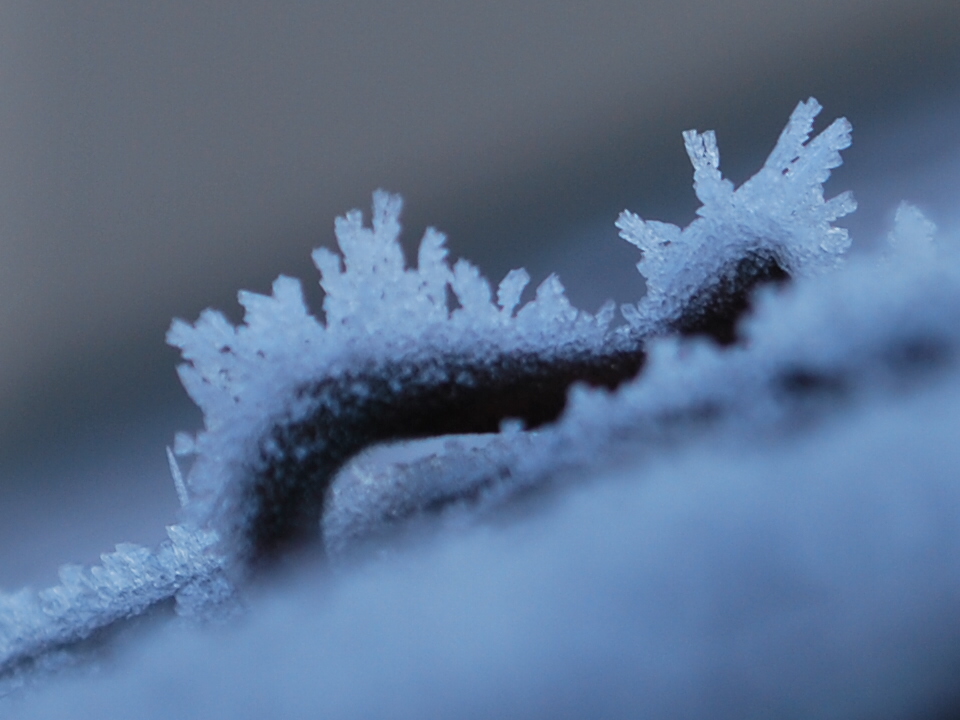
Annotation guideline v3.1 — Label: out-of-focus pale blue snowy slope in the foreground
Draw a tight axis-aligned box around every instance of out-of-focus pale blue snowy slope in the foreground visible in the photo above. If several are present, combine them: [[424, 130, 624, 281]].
[[11, 352, 960, 720]]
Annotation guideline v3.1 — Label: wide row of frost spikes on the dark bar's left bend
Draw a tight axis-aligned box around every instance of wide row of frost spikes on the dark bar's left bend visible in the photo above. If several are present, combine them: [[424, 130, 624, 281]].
[[169, 192, 613, 568]]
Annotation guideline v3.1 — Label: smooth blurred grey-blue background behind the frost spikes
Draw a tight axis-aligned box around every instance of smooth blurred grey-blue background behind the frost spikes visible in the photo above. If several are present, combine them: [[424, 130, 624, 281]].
[[0, 0, 960, 589]]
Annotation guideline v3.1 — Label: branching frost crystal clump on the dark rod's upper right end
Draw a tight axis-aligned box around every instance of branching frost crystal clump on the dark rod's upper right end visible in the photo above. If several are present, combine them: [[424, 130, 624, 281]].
[[617, 98, 856, 334]]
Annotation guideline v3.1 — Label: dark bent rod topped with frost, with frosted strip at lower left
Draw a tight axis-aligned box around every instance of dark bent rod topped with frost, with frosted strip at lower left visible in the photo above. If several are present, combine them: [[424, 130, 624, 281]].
[[0, 100, 854, 692]]
